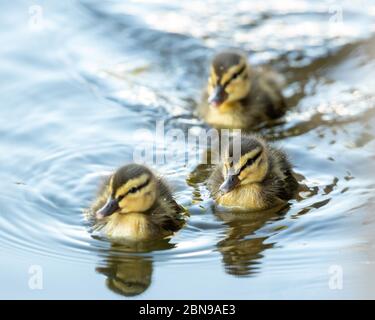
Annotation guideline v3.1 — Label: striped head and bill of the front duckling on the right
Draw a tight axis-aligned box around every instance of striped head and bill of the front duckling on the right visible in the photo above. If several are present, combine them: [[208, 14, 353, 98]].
[[220, 135, 269, 194]]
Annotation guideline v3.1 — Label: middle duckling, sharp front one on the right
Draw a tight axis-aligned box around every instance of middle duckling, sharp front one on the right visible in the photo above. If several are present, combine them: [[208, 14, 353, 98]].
[[208, 134, 298, 210]]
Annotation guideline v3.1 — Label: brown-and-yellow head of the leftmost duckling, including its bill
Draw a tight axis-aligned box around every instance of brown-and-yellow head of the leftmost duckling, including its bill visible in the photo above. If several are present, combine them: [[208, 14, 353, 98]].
[[96, 164, 158, 219]]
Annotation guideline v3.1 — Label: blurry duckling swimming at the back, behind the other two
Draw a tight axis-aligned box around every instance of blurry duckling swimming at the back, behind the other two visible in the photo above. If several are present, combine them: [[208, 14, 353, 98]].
[[198, 50, 286, 130]]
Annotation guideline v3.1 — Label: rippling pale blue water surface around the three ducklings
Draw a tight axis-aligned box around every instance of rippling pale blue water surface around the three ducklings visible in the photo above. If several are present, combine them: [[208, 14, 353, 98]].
[[0, 0, 375, 299]]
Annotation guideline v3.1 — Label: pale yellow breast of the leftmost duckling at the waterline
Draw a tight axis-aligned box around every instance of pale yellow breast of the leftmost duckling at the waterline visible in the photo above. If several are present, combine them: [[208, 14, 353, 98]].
[[104, 213, 161, 241]]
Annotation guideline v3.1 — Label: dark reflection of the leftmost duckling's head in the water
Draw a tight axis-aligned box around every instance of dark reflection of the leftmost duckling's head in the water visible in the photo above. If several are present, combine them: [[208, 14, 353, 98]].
[[96, 255, 153, 296]]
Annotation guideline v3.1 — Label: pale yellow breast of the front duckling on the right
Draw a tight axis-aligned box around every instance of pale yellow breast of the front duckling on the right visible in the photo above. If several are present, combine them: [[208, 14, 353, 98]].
[[217, 184, 267, 210]]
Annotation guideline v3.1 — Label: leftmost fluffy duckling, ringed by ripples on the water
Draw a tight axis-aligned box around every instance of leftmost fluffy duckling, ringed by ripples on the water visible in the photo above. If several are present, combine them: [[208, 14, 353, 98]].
[[88, 164, 184, 241]]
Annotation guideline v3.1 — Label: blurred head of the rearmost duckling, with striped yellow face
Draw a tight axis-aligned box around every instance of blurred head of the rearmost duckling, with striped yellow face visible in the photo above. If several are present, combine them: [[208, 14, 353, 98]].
[[208, 50, 251, 108]]
